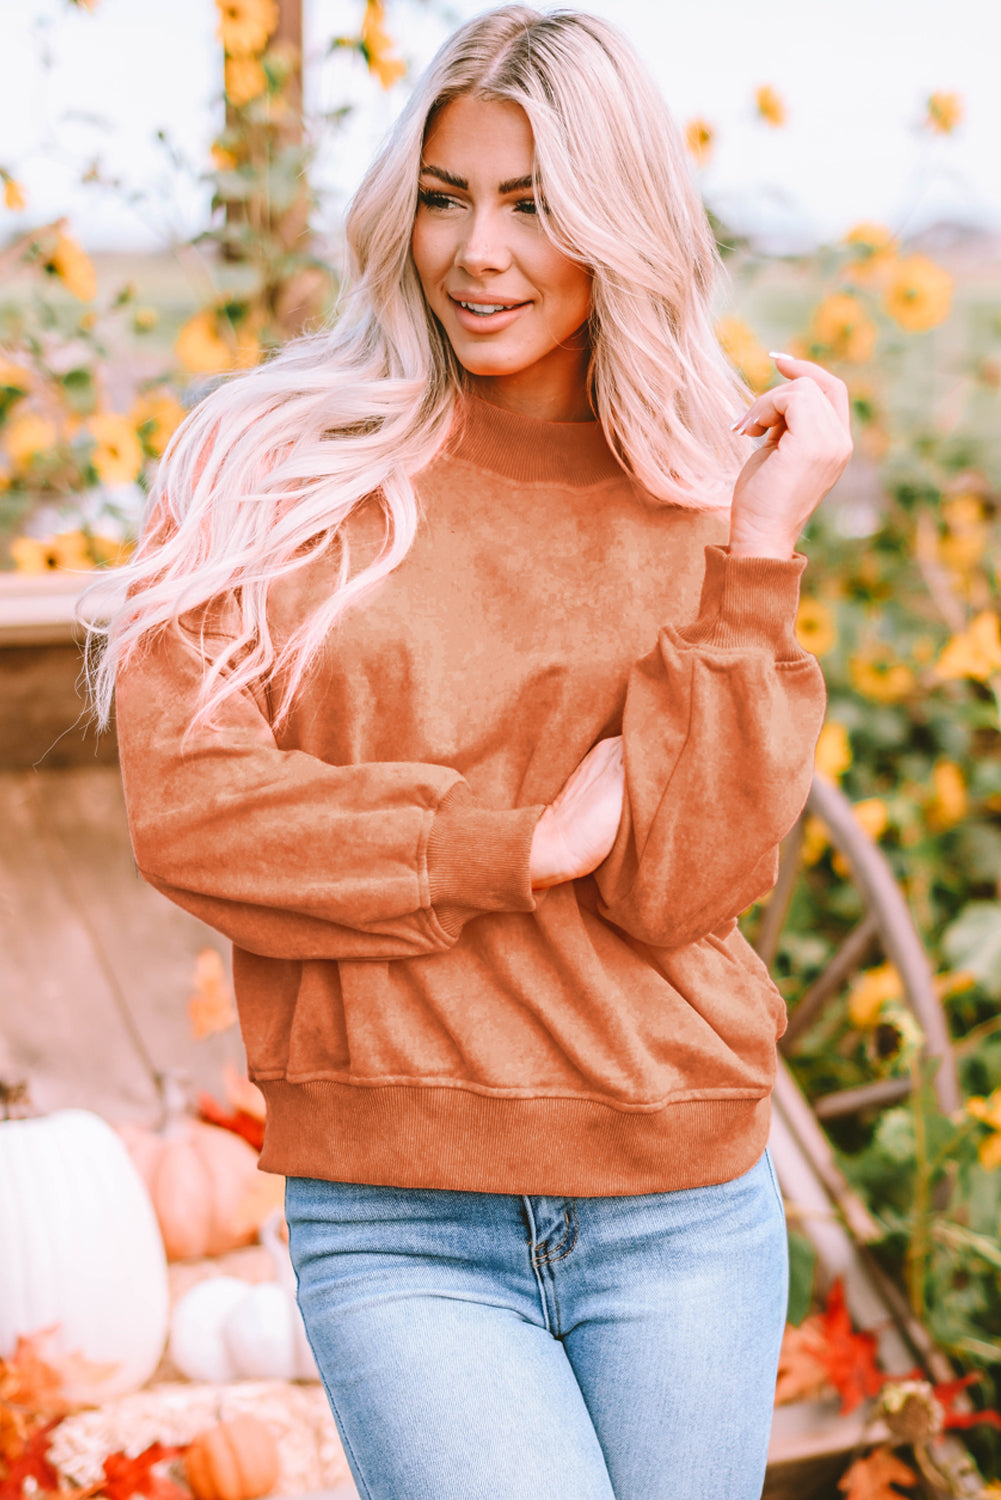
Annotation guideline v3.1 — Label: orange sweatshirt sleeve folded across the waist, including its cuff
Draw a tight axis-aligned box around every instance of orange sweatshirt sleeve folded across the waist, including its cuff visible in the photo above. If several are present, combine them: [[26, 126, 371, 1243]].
[[116, 612, 543, 960]]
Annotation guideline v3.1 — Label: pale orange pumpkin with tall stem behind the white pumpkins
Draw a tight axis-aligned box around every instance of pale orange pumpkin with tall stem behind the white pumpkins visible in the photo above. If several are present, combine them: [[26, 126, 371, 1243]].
[[119, 1079, 260, 1260]]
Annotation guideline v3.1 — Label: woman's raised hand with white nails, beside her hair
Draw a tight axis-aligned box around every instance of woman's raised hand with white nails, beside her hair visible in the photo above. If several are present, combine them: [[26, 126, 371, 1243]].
[[729, 354, 852, 557]]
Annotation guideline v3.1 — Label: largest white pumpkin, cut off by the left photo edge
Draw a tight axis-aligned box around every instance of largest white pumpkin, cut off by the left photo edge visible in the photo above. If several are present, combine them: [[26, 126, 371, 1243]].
[[0, 1110, 168, 1404]]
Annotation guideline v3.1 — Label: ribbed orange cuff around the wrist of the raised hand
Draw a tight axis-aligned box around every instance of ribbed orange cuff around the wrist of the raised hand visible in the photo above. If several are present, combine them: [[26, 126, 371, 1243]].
[[677, 543, 809, 662]]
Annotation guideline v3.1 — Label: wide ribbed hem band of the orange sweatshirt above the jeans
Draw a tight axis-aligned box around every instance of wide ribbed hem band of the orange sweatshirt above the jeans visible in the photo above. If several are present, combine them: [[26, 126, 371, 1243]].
[[257, 1079, 771, 1197]]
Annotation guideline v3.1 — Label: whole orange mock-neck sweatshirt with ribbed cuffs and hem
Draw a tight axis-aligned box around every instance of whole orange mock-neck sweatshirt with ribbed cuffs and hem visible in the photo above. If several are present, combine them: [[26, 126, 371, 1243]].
[[117, 399, 825, 1196]]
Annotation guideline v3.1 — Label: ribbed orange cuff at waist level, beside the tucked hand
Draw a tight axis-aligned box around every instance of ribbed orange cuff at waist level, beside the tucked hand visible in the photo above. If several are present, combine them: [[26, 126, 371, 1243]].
[[428, 782, 545, 936]]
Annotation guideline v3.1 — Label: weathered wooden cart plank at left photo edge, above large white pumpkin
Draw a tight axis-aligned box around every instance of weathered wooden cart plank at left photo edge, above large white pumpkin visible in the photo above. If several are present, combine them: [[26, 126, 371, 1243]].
[[0, 773, 156, 1116]]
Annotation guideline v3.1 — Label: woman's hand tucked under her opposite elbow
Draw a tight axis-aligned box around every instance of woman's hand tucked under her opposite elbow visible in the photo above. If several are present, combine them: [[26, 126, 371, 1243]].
[[530, 735, 626, 891]]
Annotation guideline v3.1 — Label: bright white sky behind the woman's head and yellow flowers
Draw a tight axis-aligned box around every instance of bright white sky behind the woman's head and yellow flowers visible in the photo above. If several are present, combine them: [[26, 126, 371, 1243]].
[[0, 0, 1001, 251]]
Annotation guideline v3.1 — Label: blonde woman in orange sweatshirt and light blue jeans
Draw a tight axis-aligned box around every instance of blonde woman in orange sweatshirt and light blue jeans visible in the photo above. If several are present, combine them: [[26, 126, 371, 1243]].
[[88, 6, 851, 1500]]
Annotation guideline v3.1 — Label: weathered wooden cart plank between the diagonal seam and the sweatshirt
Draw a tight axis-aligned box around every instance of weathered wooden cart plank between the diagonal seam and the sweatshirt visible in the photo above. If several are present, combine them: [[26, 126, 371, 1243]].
[[23, 767, 245, 1094]]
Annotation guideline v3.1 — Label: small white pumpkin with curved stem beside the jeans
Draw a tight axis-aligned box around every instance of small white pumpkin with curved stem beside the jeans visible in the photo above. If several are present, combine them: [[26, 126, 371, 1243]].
[[170, 1215, 320, 1382]]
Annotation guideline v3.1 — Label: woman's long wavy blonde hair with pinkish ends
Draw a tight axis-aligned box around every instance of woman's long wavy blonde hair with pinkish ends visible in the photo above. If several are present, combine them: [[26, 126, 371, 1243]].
[[78, 5, 750, 729]]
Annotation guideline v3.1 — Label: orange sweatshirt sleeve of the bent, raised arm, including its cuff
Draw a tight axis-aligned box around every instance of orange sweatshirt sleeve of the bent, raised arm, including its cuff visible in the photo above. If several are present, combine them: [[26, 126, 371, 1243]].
[[594, 545, 827, 948]]
